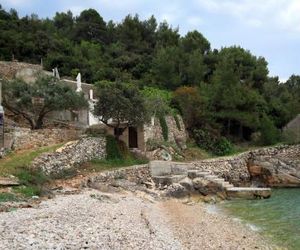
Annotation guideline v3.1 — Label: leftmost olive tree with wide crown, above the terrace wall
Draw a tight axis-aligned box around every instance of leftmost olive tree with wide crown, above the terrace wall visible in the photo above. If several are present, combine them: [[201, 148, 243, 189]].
[[3, 77, 88, 129]]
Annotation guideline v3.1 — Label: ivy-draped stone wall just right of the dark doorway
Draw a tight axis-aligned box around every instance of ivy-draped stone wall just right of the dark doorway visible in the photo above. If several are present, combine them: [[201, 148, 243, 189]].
[[144, 115, 187, 148]]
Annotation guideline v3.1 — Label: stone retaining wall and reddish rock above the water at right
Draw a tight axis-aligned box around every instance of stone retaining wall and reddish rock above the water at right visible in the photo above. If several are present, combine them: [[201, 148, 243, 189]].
[[192, 145, 300, 187]]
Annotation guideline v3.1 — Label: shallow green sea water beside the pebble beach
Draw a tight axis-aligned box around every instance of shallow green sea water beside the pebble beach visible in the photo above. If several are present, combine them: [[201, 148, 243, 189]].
[[221, 188, 300, 250]]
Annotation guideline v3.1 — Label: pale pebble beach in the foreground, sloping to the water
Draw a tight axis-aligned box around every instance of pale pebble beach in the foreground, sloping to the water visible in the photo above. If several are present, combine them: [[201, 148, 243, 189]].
[[0, 190, 271, 250]]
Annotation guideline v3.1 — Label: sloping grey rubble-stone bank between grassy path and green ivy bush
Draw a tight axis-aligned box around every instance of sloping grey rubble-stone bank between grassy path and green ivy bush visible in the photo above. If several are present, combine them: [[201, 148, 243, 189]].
[[32, 137, 106, 175]]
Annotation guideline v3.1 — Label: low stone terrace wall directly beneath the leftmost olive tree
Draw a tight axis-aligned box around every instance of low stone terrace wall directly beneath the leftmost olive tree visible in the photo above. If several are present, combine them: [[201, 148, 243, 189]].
[[5, 127, 83, 150]]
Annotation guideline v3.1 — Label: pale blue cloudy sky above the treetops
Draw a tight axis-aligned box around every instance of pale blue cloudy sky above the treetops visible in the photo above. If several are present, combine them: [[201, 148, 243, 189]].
[[1, 0, 300, 80]]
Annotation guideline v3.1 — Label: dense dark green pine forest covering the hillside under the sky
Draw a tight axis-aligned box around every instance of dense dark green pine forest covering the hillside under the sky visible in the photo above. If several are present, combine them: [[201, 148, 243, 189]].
[[0, 8, 300, 147]]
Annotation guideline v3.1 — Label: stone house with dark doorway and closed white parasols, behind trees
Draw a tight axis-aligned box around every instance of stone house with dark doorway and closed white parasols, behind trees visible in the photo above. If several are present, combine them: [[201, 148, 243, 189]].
[[0, 62, 186, 152]]
